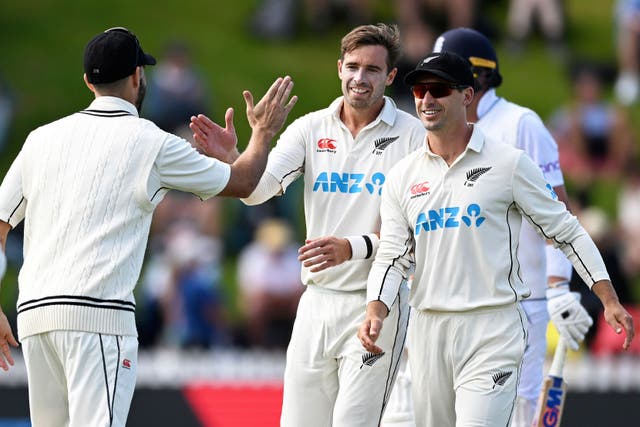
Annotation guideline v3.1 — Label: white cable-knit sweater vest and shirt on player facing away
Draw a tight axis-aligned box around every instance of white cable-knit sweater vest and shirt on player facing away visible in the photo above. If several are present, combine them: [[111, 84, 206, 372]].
[[0, 97, 230, 339]]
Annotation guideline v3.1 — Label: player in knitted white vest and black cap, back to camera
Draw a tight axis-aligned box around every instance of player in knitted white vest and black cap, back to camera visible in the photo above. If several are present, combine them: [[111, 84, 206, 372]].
[[0, 27, 297, 427]]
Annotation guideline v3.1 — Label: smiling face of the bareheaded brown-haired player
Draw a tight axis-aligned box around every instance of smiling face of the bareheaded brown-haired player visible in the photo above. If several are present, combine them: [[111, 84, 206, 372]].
[[338, 45, 397, 109]]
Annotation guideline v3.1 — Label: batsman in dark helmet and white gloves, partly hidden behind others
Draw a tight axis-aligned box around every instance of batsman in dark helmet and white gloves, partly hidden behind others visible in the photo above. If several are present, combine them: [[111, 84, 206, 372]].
[[383, 28, 593, 427]]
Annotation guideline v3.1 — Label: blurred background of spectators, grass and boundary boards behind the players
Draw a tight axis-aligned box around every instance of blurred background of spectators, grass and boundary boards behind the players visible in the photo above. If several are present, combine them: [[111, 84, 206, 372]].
[[0, 0, 640, 427]]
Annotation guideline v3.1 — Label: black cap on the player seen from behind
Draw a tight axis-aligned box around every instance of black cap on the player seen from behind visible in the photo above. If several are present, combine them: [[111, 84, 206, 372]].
[[84, 27, 156, 84]]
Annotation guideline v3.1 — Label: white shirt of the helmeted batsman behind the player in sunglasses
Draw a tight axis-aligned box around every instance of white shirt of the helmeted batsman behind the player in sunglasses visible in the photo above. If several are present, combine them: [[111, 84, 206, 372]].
[[477, 89, 564, 299]]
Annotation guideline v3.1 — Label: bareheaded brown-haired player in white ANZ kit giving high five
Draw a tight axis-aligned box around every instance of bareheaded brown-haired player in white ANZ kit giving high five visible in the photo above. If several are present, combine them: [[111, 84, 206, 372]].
[[196, 24, 425, 427]]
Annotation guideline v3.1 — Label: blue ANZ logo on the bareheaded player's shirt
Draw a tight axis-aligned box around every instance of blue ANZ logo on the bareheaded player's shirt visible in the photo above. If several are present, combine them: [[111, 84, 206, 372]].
[[313, 172, 385, 195]]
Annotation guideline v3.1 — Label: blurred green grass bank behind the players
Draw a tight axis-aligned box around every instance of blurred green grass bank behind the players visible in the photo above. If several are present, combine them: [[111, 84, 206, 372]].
[[0, 0, 638, 314]]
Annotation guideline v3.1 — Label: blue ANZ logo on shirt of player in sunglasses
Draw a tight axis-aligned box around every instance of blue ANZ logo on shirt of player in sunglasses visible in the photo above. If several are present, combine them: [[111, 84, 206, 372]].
[[415, 203, 486, 236]]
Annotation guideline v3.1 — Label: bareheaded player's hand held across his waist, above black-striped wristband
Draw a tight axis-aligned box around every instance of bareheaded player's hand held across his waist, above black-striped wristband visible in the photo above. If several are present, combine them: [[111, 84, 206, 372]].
[[298, 236, 351, 273]]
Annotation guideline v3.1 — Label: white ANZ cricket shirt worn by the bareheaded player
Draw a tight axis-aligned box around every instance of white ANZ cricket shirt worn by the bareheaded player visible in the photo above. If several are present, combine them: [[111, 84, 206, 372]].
[[266, 97, 426, 291]]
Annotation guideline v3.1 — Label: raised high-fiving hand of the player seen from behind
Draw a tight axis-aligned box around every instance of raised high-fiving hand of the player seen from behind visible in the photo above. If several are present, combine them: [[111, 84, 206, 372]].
[[242, 76, 298, 137]]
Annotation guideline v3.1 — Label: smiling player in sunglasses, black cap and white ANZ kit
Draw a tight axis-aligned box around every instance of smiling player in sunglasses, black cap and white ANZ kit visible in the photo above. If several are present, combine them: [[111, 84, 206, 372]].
[[358, 52, 634, 427]]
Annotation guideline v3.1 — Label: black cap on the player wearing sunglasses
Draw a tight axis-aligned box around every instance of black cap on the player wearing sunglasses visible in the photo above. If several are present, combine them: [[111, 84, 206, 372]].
[[404, 52, 473, 87]]
